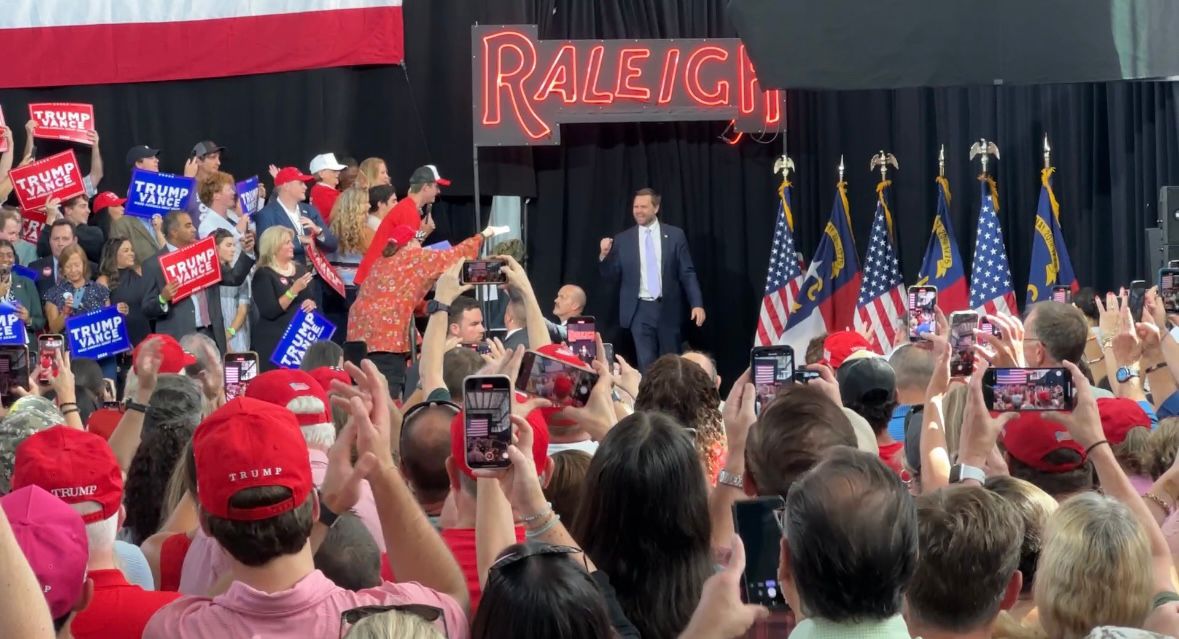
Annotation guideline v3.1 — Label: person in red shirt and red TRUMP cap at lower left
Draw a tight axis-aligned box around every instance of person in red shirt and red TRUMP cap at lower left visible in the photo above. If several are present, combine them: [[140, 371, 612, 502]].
[[12, 426, 179, 639]]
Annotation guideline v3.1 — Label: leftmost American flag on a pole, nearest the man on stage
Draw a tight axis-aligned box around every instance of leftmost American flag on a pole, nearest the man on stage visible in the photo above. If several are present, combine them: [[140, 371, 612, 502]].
[[757, 185, 805, 347]]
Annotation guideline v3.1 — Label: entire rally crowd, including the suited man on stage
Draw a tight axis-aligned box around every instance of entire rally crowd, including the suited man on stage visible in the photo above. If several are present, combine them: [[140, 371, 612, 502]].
[[0, 119, 1179, 639]]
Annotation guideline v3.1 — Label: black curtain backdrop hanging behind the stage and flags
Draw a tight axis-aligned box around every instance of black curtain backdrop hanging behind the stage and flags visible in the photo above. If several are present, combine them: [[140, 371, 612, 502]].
[[0, 0, 1179, 386]]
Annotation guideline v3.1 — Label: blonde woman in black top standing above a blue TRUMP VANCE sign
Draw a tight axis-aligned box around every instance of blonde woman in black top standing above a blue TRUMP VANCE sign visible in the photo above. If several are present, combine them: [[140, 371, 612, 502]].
[[251, 225, 316, 370]]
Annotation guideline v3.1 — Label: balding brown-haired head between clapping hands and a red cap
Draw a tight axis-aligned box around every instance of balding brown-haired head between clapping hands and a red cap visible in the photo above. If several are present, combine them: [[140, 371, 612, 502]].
[[401, 407, 454, 503]]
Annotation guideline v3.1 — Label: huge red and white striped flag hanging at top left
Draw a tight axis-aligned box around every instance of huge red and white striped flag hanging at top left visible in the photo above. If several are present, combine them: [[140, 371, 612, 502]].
[[0, 0, 406, 88]]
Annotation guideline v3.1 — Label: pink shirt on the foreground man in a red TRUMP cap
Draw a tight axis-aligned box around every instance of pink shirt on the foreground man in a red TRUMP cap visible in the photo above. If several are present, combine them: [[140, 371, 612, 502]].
[[144, 571, 470, 639]]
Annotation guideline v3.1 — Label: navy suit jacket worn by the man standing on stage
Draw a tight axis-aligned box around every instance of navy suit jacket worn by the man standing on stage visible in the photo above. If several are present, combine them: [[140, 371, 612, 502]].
[[598, 220, 704, 327]]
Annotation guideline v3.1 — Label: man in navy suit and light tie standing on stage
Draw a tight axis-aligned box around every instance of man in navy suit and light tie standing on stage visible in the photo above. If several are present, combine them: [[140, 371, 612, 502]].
[[598, 189, 705, 371]]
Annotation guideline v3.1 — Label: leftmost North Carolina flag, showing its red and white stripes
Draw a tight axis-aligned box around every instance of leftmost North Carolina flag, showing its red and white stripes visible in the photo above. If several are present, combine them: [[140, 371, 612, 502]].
[[780, 182, 861, 353]]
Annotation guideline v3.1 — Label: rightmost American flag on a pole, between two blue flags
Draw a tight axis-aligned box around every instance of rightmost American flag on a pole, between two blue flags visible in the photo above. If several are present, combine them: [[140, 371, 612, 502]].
[[970, 187, 1016, 315]]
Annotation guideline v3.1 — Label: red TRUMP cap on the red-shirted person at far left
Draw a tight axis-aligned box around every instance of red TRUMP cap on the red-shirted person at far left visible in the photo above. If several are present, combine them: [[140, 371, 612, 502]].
[[12, 426, 123, 523]]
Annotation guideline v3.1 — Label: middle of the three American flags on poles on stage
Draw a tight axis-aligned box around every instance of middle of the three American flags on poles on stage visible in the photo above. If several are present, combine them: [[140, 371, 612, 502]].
[[856, 192, 905, 353]]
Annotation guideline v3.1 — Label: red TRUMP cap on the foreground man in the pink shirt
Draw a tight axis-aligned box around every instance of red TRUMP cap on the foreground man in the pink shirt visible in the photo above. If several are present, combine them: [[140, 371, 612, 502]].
[[192, 398, 312, 521]]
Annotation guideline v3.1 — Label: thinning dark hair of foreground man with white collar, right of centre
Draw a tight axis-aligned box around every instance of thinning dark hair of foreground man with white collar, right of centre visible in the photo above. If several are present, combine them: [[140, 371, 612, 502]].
[[785, 446, 917, 621]]
